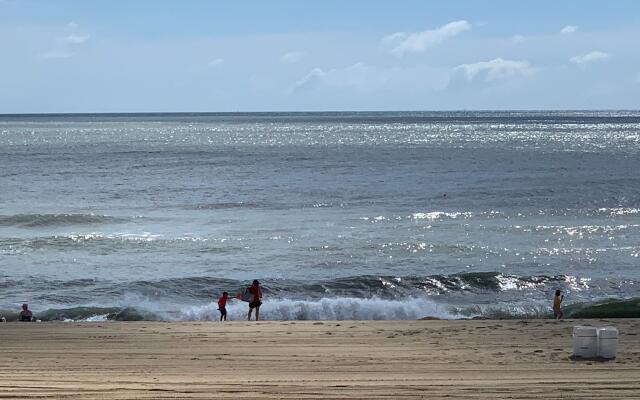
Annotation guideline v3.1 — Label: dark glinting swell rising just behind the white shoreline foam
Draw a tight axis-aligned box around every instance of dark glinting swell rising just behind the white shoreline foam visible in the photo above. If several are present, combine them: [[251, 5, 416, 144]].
[[0, 272, 608, 304]]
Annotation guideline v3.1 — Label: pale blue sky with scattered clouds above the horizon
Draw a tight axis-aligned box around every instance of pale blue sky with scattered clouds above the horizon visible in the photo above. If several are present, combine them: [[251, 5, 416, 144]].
[[0, 0, 640, 113]]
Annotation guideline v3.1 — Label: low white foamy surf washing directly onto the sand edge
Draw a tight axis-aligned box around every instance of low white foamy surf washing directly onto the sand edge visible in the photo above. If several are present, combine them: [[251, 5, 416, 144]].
[[0, 297, 640, 322]]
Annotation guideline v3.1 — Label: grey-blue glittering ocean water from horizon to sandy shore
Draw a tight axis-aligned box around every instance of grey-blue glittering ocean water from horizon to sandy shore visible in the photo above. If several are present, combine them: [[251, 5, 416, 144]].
[[0, 111, 640, 320]]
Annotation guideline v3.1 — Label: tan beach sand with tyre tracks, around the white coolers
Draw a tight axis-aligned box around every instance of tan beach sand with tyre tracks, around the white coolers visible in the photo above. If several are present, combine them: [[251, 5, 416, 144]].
[[0, 319, 640, 399]]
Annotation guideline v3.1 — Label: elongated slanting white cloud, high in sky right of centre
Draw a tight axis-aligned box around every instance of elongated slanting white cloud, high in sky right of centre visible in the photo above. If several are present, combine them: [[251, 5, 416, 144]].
[[382, 20, 471, 56]]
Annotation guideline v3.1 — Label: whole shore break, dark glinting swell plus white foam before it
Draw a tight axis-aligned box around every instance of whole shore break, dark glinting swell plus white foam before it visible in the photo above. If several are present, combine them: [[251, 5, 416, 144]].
[[0, 272, 640, 321]]
